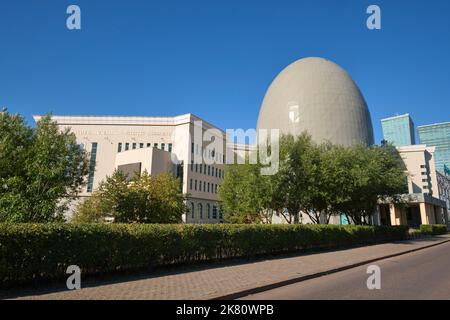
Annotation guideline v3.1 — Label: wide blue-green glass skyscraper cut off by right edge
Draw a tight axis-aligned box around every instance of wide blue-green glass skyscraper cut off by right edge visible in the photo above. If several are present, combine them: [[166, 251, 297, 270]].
[[417, 122, 450, 173]]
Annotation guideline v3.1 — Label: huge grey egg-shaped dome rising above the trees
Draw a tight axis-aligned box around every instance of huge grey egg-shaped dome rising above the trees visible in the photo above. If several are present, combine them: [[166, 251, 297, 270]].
[[258, 58, 374, 146]]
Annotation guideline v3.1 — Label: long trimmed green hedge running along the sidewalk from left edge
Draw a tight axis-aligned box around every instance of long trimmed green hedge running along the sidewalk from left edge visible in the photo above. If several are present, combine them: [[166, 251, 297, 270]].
[[0, 224, 408, 284]]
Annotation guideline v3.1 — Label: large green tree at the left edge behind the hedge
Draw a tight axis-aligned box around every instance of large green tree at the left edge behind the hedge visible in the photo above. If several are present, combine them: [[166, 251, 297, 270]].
[[0, 110, 88, 222]]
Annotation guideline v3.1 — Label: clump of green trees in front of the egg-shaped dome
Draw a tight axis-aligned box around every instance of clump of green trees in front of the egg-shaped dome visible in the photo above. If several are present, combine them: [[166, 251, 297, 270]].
[[220, 133, 406, 224]]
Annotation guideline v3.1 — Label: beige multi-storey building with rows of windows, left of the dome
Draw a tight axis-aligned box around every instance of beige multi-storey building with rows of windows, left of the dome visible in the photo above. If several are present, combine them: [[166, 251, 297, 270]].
[[34, 114, 226, 223]]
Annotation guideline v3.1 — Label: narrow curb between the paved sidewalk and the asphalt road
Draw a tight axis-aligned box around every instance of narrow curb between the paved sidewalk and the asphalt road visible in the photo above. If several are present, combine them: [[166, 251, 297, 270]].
[[209, 235, 450, 300]]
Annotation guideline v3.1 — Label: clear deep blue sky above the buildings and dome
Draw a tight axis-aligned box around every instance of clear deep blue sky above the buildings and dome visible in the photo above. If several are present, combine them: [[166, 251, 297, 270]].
[[0, 0, 450, 142]]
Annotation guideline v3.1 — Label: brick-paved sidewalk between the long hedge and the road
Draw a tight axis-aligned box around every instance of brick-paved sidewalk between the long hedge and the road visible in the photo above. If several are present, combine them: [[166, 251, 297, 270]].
[[4, 236, 450, 300]]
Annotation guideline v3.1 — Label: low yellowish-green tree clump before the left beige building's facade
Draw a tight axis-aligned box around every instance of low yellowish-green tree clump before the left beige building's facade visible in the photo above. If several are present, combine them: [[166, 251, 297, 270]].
[[72, 170, 186, 223]]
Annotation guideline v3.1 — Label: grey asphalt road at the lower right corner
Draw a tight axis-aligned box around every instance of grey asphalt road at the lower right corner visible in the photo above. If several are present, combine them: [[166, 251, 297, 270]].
[[243, 243, 450, 300]]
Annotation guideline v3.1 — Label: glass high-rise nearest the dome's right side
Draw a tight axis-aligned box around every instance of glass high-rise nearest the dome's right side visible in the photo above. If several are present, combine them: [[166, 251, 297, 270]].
[[381, 114, 416, 147]]
